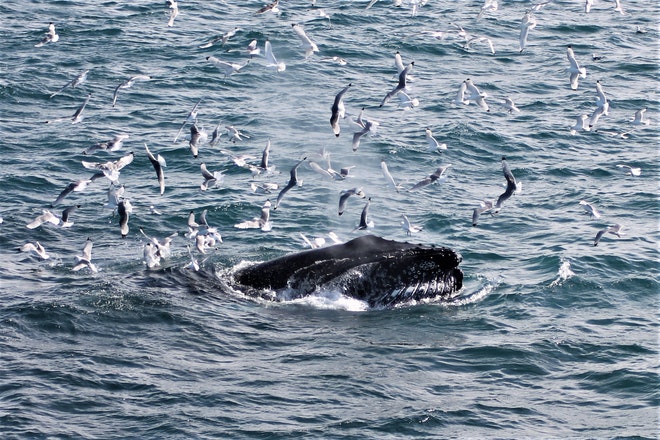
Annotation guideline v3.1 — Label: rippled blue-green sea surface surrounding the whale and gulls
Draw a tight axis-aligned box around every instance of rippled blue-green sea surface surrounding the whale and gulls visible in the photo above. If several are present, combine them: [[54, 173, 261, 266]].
[[0, 0, 660, 439]]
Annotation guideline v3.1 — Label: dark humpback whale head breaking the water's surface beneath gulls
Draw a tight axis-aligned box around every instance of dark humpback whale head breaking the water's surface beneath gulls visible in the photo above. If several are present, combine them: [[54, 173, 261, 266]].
[[234, 235, 463, 308]]
